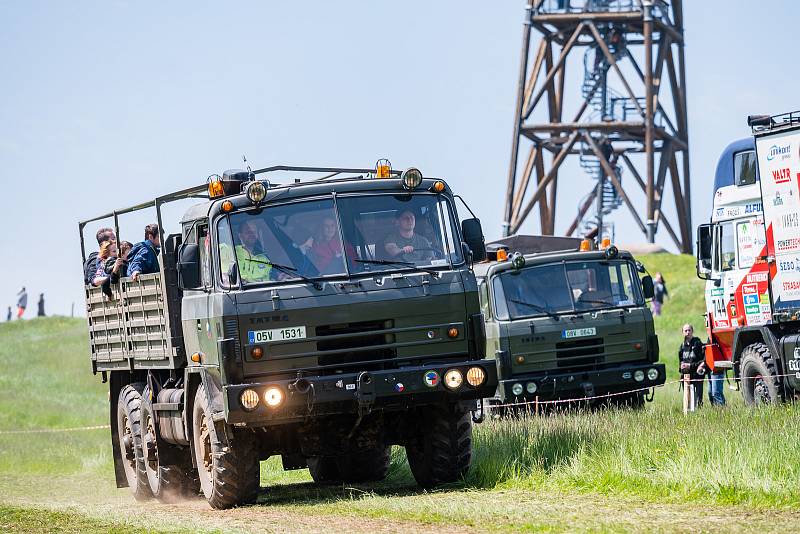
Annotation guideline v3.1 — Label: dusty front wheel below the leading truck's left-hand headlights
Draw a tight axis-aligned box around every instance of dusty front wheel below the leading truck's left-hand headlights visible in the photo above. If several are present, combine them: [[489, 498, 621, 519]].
[[192, 386, 261, 510]]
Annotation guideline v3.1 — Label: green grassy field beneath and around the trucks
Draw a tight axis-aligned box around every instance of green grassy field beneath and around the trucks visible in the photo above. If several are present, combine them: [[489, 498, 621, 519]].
[[0, 255, 800, 532]]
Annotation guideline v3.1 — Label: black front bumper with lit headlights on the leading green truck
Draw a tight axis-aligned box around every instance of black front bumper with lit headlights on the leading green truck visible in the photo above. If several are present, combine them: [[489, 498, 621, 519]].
[[223, 360, 498, 426]]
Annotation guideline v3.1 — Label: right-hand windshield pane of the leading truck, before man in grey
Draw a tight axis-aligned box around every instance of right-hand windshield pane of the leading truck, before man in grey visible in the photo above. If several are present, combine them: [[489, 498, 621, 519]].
[[336, 194, 463, 273]]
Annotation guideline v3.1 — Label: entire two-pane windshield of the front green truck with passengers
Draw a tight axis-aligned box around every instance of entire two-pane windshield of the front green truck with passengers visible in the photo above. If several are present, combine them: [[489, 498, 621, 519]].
[[217, 194, 461, 287]]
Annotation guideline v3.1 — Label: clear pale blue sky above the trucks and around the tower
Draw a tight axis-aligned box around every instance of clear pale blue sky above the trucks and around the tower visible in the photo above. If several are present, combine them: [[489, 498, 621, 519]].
[[0, 0, 800, 319]]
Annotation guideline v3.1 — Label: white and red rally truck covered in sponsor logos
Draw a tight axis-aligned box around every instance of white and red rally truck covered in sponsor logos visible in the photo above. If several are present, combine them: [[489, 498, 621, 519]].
[[697, 112, 800, 404]]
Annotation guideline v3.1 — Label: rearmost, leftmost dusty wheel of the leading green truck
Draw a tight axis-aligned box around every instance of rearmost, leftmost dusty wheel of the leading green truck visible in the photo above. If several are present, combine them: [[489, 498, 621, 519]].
[[117, 382, 153, 501]]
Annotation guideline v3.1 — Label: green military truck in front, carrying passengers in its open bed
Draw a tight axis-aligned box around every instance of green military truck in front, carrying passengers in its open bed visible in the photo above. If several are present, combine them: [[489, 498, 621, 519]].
[[80, 165, 497, 508]]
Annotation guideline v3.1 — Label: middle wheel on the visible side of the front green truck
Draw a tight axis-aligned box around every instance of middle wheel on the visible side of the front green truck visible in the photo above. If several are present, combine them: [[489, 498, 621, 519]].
[[141, 389, 198, 504]]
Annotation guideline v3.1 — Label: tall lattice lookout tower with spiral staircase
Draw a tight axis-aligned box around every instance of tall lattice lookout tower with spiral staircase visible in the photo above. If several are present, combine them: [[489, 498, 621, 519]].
[[503, 0, 692, 253]]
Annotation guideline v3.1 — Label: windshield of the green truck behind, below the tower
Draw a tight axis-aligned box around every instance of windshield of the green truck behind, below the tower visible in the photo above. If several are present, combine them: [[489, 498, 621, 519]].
[[493, 260, 644, 319]]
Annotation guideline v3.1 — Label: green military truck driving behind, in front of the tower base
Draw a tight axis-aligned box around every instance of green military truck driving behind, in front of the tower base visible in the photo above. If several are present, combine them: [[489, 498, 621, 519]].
[[474, 236, 666, 406]]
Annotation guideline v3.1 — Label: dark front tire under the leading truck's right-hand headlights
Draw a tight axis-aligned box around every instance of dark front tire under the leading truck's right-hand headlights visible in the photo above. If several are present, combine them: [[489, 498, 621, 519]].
[[406, 406, 472, 488]]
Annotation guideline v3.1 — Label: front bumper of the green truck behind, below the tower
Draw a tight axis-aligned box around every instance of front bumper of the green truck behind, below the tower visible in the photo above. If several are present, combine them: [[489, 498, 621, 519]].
[[497, 362, 667, 402]]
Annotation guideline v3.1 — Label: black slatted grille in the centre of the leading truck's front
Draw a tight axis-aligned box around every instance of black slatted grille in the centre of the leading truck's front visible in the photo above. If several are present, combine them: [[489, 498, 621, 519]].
[[316, 319, 397, 374]]
